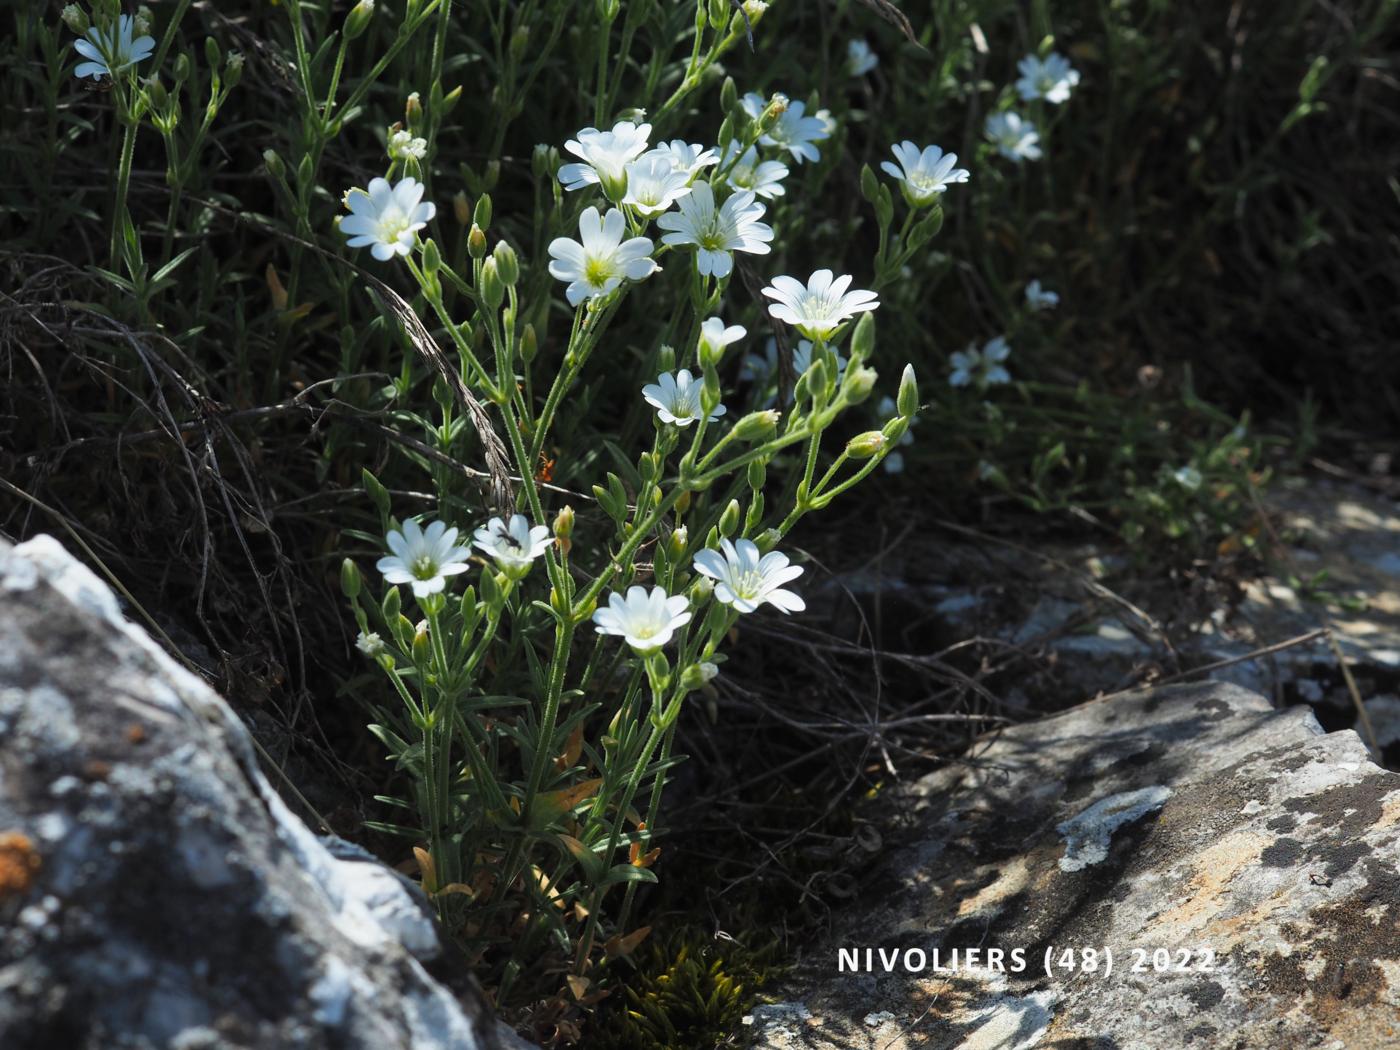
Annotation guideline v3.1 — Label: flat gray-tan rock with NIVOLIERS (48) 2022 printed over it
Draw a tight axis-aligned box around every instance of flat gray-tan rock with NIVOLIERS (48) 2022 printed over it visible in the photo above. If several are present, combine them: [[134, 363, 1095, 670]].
[[749, 683, 1400, 1050]]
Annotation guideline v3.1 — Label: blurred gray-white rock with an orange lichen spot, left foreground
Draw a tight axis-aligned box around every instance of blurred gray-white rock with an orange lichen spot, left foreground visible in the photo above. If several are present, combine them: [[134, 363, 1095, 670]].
[[0, 536, 532, 1050]]
